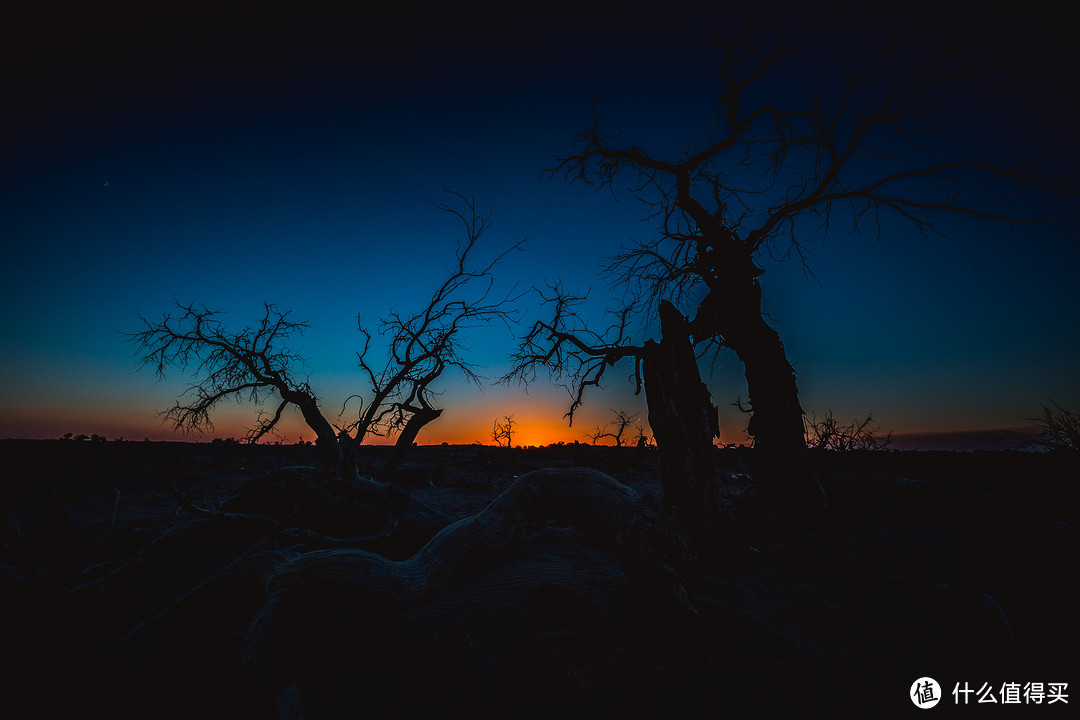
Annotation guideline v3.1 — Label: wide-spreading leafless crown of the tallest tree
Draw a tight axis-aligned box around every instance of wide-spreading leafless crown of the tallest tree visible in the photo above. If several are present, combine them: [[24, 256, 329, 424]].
[[565, 35, 1076, 317]]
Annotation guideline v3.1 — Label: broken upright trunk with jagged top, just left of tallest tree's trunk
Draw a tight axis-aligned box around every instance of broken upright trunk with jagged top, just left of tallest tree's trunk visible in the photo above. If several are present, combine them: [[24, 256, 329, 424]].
[[643, 300, 727, 552]]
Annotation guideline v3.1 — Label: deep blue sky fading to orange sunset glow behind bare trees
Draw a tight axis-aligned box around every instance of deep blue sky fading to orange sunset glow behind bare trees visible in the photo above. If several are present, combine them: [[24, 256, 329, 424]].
[[0, 2, 1080, 447]]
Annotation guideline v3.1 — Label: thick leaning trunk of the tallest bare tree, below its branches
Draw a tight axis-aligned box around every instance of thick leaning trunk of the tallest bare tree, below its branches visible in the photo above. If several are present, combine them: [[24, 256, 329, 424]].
[[693, 276, 826, 516]]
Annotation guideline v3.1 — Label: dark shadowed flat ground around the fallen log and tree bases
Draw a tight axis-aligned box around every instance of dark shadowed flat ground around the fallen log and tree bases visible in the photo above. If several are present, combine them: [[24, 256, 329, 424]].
[[0, 440, 1080, 718]]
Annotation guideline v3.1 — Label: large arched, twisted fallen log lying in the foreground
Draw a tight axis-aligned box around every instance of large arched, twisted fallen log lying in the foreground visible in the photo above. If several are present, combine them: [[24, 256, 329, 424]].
[[244, 467, 697, 718]]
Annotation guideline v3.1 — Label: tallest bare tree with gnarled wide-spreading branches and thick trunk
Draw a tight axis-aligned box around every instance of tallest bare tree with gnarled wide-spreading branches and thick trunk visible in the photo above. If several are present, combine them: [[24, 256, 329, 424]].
[[512, 33, 1072, 524]]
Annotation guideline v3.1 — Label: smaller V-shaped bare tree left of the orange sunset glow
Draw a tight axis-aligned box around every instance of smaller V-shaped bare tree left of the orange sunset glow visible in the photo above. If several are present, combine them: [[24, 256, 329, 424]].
[[129, 195, 521, 477]]
